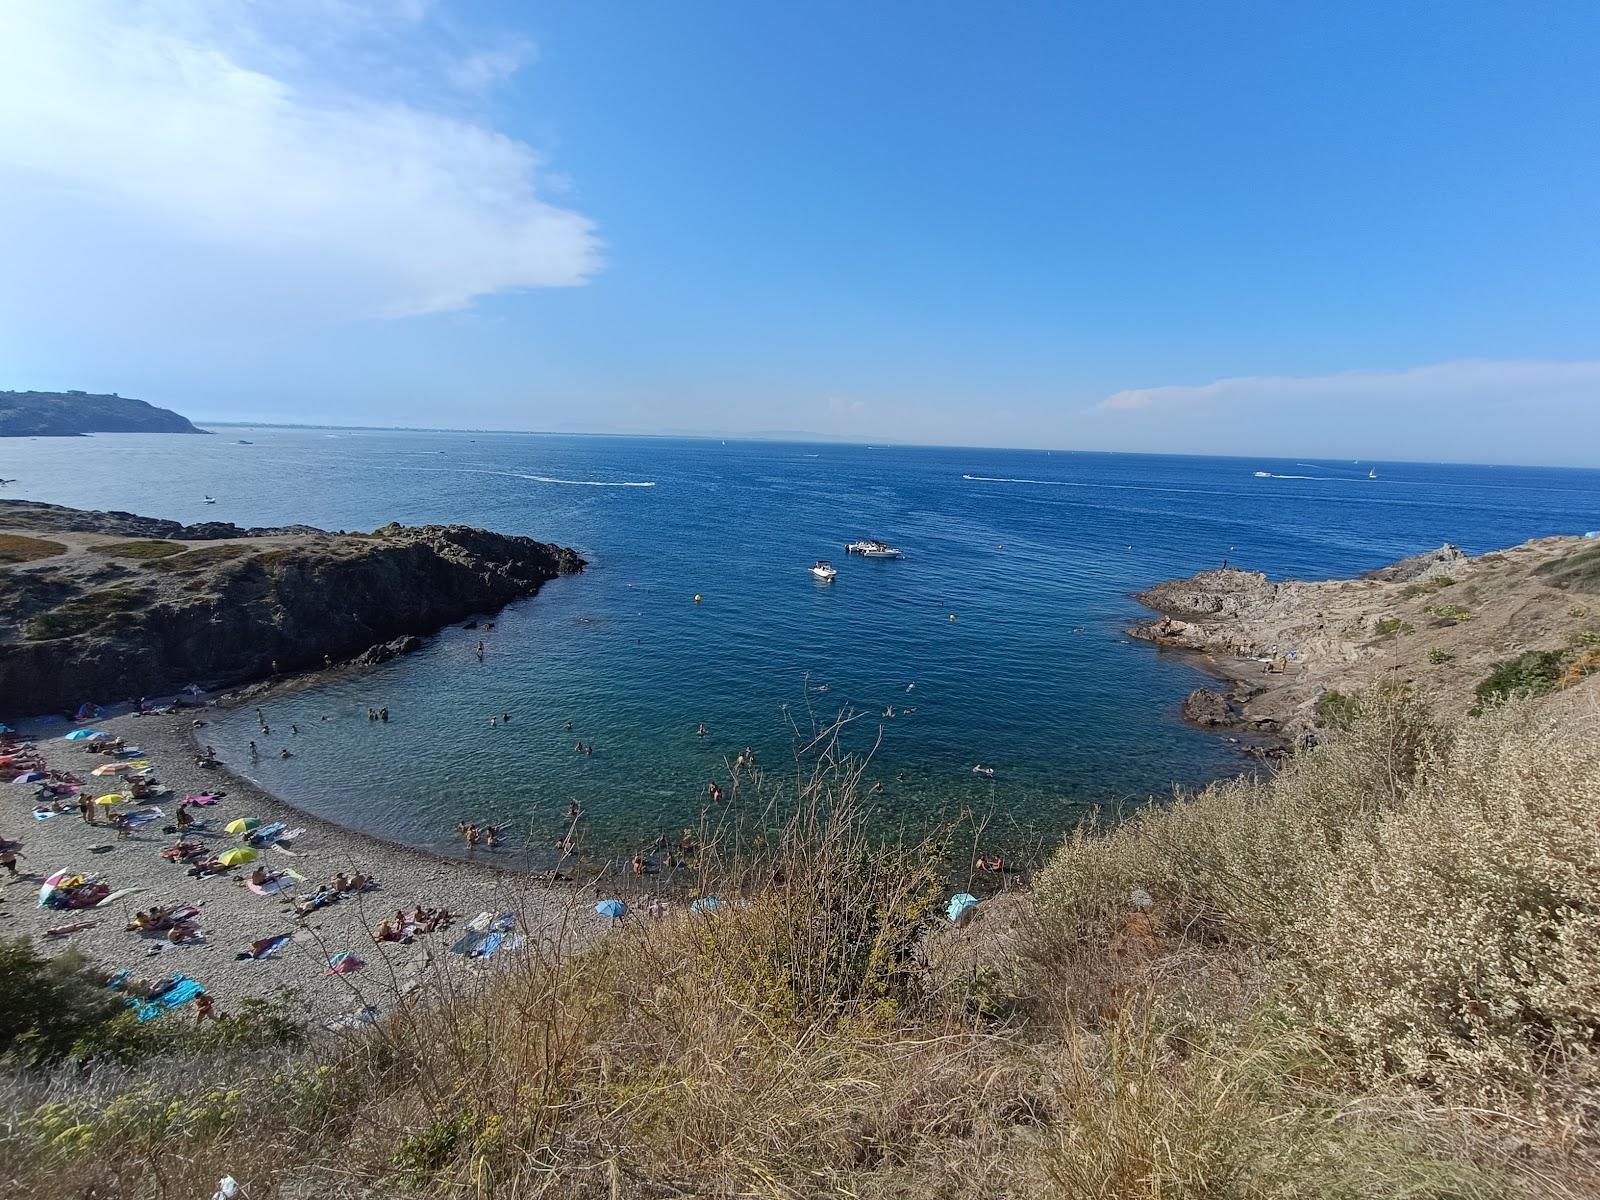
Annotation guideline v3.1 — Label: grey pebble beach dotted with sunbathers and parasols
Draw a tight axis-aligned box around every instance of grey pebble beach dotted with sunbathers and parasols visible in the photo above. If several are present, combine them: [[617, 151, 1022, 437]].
[[0, 709, 606, 1019]]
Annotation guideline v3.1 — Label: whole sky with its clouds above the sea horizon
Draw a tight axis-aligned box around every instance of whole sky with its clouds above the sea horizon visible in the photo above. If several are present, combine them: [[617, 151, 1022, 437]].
[[0, 0, 1600, 466]]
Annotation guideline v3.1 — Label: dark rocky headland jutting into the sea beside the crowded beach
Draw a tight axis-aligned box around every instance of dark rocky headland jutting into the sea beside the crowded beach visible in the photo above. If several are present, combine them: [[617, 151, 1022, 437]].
[[0, 501, 584, 715]]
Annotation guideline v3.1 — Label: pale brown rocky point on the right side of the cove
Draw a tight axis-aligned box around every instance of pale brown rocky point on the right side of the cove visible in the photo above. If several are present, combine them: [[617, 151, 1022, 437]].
[[1130, 538, 1600, 746]]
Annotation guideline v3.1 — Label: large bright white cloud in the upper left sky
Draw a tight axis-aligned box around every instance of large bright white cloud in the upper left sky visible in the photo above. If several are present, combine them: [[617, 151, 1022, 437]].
[[0, 0, 602, 336]]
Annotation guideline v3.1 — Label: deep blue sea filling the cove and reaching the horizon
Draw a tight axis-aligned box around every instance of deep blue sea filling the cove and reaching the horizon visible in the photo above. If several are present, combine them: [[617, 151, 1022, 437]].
[[0, 429, 1600, 848]]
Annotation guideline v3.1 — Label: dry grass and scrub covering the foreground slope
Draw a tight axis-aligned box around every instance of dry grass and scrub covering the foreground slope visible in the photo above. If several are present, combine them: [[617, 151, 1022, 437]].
[[0, 694, 1600, 1200]]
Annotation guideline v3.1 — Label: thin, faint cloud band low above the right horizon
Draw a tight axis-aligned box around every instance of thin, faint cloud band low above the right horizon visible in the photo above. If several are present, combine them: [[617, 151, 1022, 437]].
[[1098, 358, 1600, 411]]
